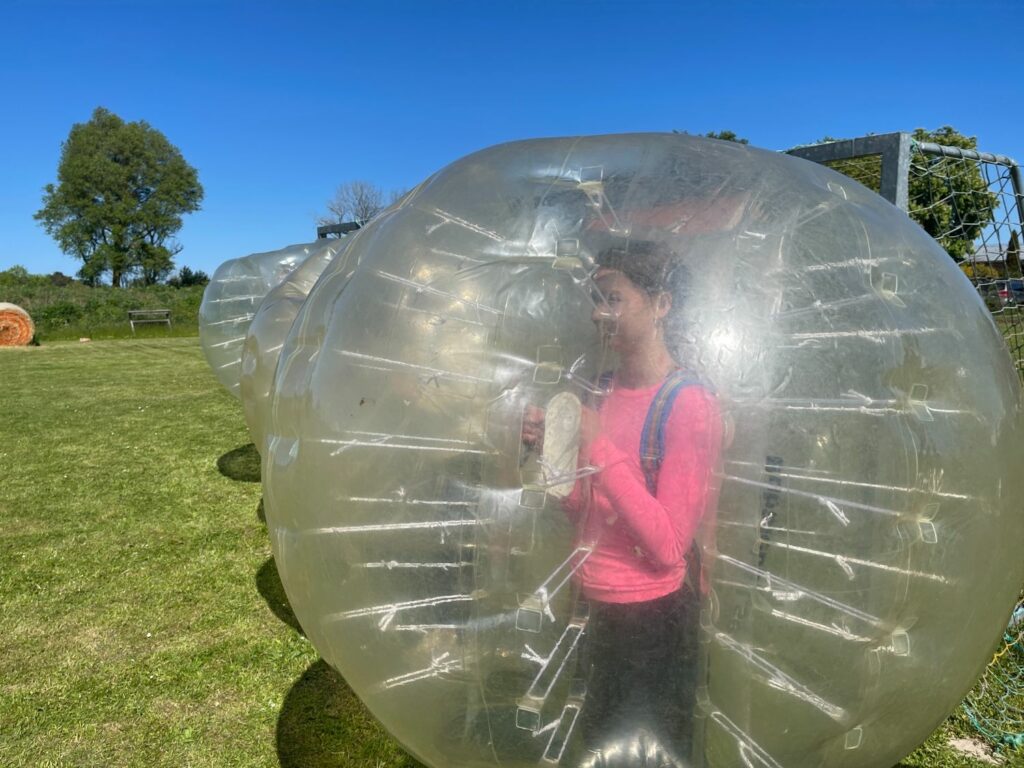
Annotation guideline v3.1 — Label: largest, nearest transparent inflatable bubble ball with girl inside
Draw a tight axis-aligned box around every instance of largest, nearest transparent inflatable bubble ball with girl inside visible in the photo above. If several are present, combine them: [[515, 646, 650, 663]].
[[263, 135, 1024, 768]]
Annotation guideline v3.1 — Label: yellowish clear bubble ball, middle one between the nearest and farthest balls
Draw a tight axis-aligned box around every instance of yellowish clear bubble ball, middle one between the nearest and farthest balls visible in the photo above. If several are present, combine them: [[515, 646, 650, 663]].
[[239, 238, 352, 452]]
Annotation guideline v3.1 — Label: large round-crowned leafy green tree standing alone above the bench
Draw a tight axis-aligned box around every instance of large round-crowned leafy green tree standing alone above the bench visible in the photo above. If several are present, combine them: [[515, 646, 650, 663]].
[[35, 106, 203, 287]]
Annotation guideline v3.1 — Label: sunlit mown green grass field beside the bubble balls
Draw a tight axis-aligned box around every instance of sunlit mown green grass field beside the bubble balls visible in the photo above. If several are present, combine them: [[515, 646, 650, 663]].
[[0, 338, 1024, 768]]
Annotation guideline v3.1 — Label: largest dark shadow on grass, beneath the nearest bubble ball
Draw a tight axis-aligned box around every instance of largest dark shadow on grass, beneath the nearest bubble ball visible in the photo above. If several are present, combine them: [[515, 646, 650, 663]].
[[278, 659, 422, 768]]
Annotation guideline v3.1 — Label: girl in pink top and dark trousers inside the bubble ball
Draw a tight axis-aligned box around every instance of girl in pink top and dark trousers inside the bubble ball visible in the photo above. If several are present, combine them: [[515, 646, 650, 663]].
[[523, 240, 722, 765]]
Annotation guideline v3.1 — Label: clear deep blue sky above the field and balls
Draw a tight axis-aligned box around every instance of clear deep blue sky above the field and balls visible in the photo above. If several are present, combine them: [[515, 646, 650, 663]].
[[0, 0, 1024, 273]]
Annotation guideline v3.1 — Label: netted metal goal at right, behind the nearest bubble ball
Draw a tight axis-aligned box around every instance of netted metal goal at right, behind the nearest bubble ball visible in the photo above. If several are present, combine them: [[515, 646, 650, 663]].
[[791, 133, 1024, 748]]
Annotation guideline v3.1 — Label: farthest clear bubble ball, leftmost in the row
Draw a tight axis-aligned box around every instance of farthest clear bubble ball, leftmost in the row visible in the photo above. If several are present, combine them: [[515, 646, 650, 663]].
[[199, 241, 315, 397]]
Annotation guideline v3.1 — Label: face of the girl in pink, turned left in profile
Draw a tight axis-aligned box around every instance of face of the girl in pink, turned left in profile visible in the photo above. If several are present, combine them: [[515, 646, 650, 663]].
[[591, 267, 672, 352]]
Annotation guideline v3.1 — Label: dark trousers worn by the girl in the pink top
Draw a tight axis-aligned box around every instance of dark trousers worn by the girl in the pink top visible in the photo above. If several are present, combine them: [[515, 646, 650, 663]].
[[580, 586, 699, 765]]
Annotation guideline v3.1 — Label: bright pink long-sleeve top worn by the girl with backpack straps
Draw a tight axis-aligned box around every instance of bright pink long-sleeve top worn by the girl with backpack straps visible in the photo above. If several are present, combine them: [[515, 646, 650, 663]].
[[565, 385, 722, 603]]
